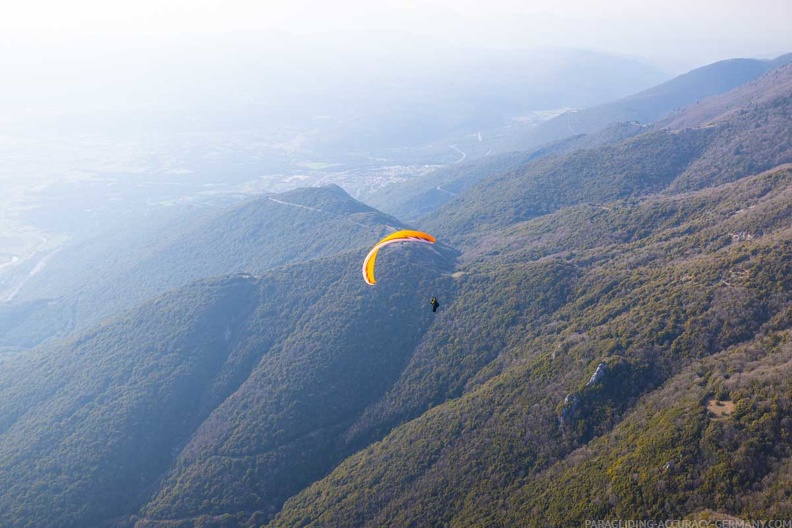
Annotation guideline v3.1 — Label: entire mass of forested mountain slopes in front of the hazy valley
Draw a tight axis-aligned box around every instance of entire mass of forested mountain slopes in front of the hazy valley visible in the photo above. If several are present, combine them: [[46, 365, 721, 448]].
[[0, 50, 792, 528]]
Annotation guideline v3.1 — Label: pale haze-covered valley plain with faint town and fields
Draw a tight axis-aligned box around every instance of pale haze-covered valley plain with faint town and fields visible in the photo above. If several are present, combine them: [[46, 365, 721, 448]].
[[0, 36, 676, 299]]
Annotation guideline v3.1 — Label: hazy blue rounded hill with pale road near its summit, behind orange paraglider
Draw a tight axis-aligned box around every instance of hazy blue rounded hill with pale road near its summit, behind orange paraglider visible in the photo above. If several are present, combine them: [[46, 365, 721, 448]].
[[0, 186, 402, 347]]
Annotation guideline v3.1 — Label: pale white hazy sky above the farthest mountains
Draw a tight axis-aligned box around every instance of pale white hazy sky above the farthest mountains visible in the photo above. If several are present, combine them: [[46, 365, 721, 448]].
[[0, 0, 792, 73]]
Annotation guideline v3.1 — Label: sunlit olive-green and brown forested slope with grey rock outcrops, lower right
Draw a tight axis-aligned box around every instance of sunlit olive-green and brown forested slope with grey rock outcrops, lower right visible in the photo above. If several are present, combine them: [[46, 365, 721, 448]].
[[273, 168, 792, 526]]
